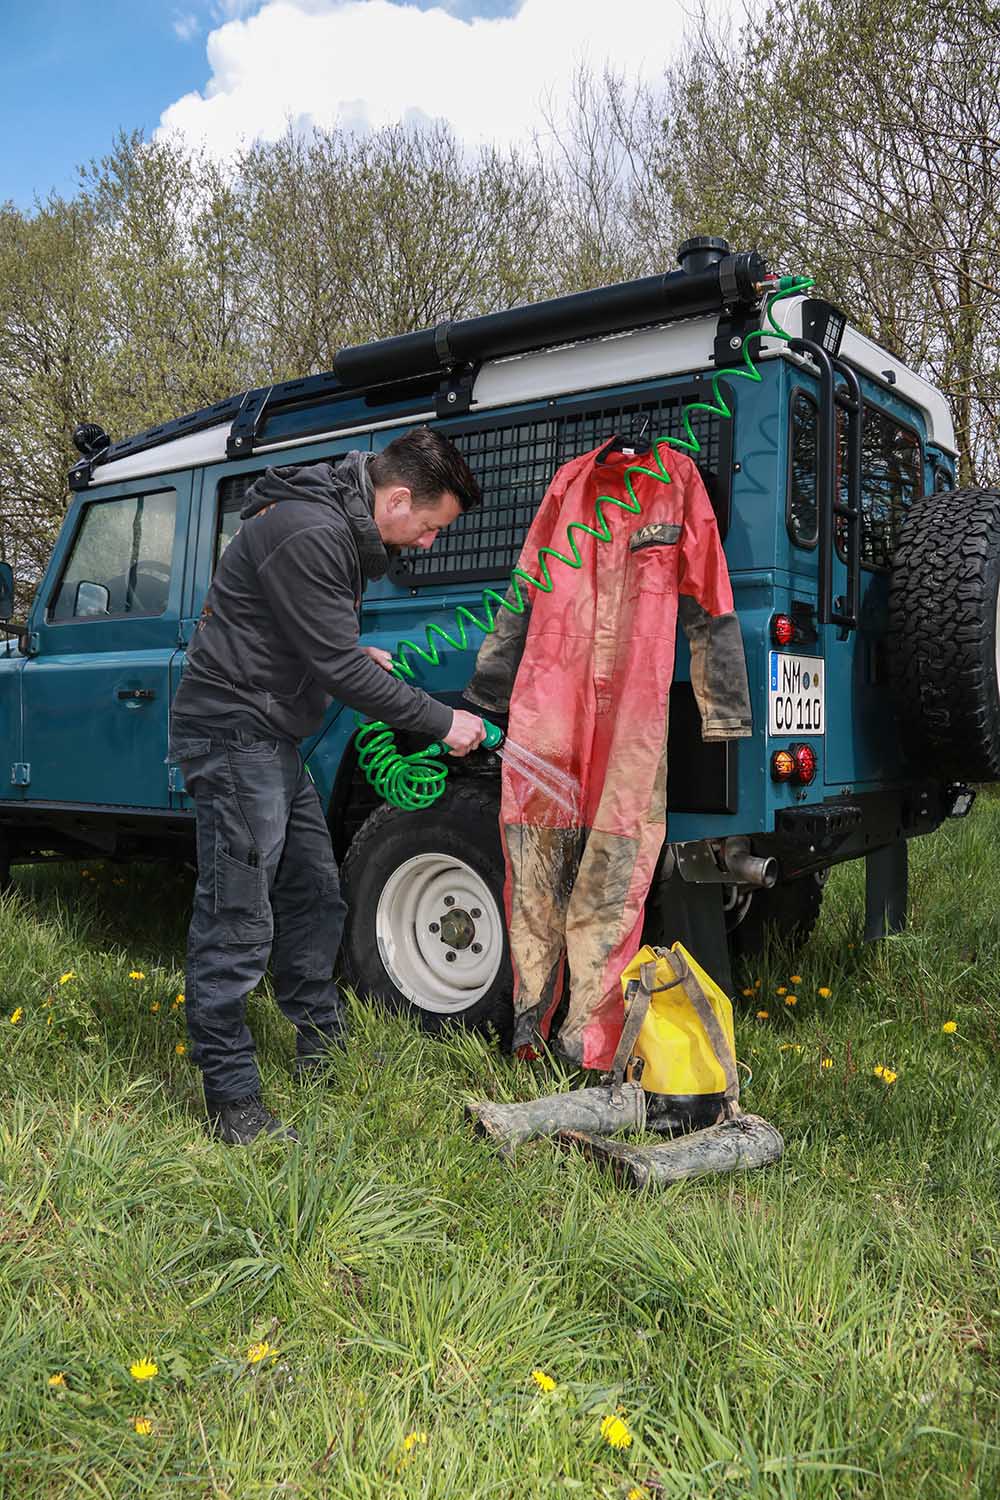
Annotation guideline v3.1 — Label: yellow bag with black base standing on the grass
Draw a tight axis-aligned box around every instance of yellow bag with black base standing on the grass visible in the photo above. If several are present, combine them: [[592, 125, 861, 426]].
[[612, 942, 739, 1124]]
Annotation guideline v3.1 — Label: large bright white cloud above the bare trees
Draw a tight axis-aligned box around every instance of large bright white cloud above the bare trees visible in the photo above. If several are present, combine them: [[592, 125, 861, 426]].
[[157, 0, 719, 158]]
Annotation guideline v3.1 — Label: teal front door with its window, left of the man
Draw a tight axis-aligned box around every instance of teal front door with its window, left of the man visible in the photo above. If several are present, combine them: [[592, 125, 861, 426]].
[[21, 473, 192, 807]]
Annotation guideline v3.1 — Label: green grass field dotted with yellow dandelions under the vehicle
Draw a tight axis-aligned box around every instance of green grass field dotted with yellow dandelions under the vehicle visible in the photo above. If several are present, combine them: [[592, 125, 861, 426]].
[[0, 797, 1000, 1500]]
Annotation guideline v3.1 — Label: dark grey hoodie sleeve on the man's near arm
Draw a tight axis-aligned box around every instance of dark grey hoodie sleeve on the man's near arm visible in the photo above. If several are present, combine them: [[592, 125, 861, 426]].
[[256, 527, 454, 740]]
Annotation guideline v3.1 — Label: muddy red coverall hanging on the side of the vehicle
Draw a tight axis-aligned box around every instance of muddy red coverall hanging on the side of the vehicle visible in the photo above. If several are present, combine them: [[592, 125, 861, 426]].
[[466, 444, 751, 1068]]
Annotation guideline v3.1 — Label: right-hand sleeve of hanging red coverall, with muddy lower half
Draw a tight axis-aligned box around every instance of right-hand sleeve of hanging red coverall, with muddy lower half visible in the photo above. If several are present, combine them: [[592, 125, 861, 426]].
[[678, 465, 753, 740]]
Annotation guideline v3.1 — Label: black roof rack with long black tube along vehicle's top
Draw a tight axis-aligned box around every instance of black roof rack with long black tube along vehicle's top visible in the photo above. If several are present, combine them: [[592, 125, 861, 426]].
[[69, 236, 768, 489]]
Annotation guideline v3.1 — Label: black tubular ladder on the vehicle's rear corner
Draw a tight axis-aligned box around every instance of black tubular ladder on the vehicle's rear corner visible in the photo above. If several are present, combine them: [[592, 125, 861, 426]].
[[789, 339, 862, 639]]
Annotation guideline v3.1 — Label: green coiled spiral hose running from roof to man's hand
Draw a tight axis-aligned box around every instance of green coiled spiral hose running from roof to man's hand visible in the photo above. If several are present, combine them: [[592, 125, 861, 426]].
[[355, 276, 813, 812]]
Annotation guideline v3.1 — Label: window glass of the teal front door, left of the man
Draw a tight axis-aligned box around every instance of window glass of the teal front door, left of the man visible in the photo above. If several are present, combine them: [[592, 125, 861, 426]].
[[46, 489, 177, 623]]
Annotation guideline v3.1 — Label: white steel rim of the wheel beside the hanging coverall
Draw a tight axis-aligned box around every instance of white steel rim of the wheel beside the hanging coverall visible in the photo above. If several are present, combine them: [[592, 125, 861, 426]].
[[375, 854, 504, 1016]]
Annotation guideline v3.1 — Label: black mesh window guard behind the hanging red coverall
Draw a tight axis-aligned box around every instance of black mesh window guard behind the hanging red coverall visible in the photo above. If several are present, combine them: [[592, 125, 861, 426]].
[[390, 386, 733, 588]]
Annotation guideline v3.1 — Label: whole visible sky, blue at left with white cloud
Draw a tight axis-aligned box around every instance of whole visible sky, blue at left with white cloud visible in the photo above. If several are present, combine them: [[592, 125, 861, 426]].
[[0, 0, 689, 210]]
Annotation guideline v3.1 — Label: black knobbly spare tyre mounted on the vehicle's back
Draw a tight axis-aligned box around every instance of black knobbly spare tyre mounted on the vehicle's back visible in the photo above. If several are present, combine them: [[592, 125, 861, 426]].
[[888, 489, 1000, 782]]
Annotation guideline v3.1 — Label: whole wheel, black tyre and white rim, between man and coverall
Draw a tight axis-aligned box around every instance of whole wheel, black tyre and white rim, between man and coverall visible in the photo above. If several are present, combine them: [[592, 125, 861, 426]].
[[342, 786, 513, 1037]]
